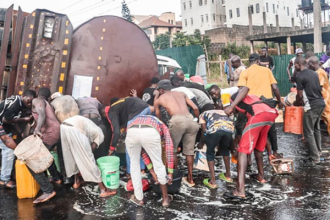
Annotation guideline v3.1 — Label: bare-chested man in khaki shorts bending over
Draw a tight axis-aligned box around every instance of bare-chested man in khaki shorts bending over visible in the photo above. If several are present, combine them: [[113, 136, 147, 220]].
[[154, 80, 199, 187]]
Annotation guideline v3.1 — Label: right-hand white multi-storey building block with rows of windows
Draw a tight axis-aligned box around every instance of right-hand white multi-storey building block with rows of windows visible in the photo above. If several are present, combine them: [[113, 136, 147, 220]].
[[225, 0, 301, 27]]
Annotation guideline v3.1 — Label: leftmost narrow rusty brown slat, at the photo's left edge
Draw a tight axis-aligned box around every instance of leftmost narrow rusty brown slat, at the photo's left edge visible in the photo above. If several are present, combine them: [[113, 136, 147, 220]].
[[0, 4, 14, 99]]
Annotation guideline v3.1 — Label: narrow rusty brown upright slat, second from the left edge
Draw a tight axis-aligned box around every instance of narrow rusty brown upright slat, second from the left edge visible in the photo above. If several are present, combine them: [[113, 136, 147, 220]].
[[7, 7, 24, 97]]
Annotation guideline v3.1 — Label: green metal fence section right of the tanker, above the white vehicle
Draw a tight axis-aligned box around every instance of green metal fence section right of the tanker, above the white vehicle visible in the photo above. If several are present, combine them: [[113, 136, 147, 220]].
[[155, 45, 204, 76]]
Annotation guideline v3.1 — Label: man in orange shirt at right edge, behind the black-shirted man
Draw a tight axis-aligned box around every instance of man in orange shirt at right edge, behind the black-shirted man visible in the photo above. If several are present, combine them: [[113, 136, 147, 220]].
[[308, 56, 330, 135]]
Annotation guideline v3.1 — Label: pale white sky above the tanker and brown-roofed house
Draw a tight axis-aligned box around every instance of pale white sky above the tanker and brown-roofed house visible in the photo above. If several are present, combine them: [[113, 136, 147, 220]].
[[0, 0, 181, 27]]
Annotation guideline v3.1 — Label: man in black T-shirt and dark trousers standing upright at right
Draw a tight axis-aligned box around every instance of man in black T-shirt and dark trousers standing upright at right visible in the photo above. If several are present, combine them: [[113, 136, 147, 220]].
[[294, 57, 325, 164]]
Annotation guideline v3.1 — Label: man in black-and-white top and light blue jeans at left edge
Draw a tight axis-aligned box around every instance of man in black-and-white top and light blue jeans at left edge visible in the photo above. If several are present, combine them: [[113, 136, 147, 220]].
[[0, 90, 36, 189]]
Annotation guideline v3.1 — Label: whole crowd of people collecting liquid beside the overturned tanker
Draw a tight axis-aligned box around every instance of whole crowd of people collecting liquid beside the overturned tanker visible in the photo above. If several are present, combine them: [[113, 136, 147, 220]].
[[0, 48, 330, 207]]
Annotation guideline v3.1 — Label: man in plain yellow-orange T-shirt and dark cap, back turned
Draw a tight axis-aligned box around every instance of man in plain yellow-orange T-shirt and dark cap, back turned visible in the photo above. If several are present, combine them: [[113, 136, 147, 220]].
[[237, 54, 284, 160]]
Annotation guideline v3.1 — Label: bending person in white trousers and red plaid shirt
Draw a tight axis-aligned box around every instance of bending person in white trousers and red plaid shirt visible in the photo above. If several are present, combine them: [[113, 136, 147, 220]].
[[125, 116, 174, 207]]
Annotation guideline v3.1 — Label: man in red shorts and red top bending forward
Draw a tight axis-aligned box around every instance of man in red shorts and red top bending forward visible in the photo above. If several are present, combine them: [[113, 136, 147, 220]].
[[225, 87, 278, 199]]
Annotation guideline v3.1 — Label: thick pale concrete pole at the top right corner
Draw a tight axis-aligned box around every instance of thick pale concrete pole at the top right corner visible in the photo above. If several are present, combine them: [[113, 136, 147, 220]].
[[313, 0, 323, 53]]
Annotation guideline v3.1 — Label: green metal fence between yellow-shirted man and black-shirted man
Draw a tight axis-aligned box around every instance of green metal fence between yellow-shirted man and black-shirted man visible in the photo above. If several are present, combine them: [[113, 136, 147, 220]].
[[273, 53, 323, 96]]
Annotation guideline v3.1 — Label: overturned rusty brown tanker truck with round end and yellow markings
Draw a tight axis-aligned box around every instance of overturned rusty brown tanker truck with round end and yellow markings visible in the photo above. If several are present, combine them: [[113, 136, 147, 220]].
[[0, 7, 158, 105]]
